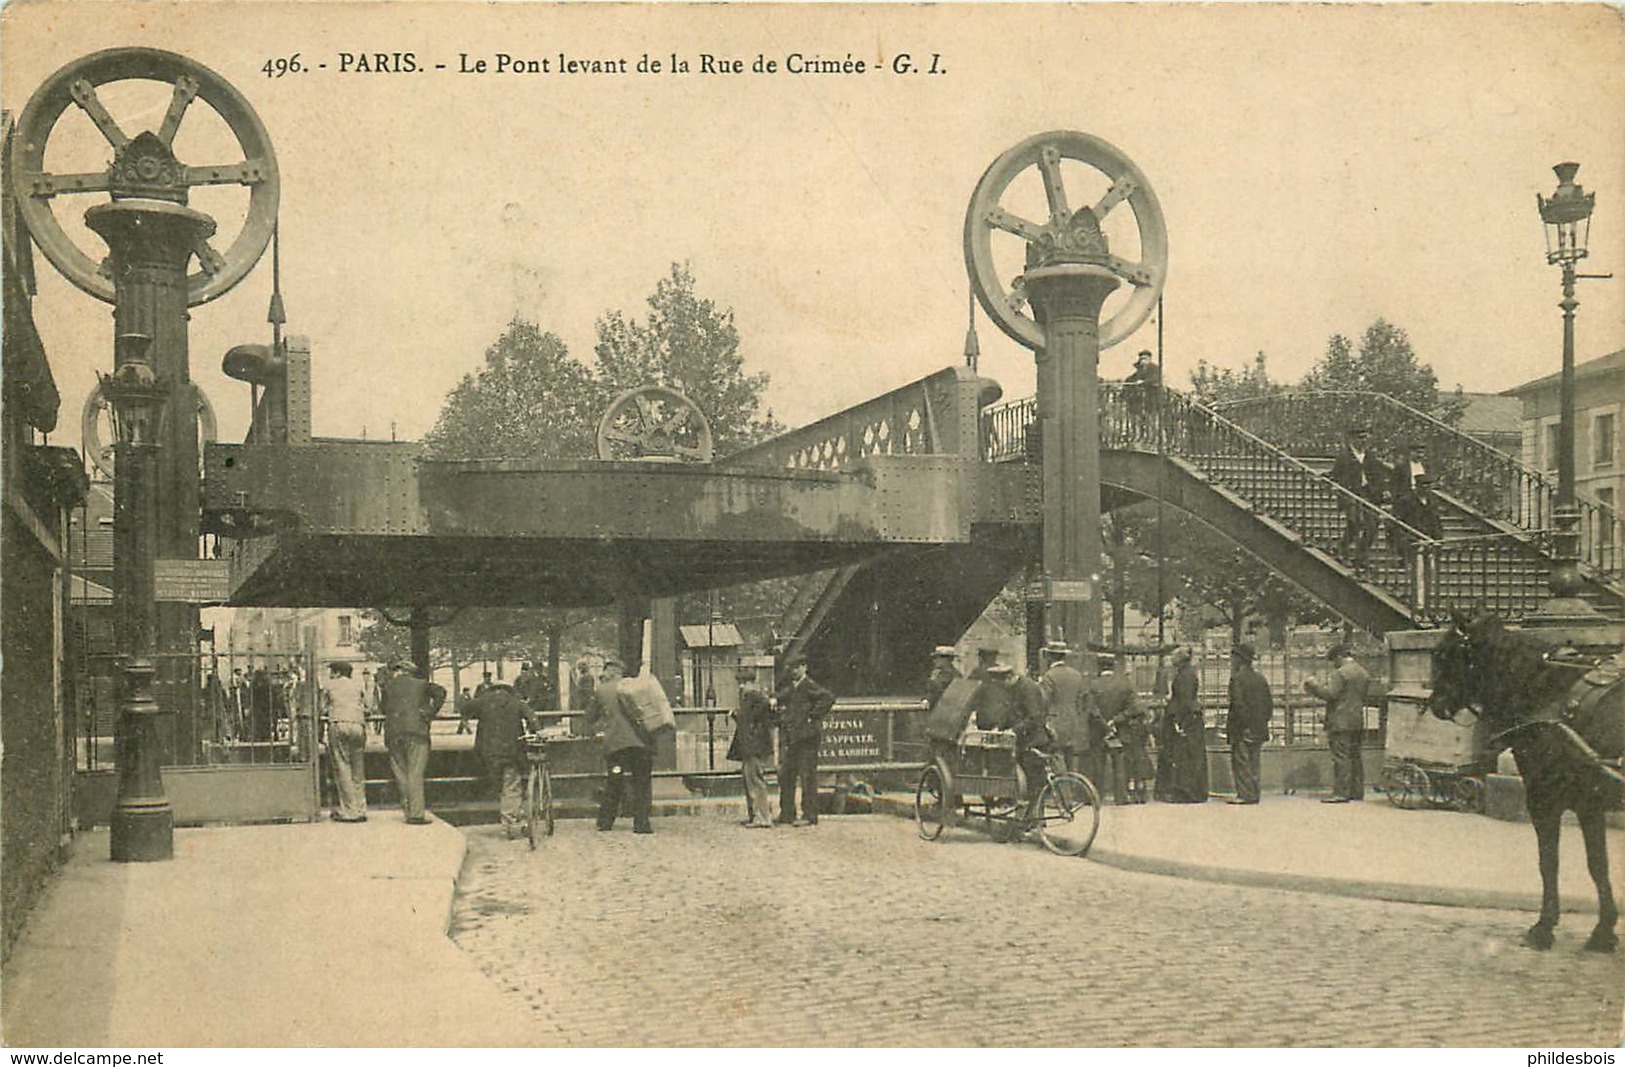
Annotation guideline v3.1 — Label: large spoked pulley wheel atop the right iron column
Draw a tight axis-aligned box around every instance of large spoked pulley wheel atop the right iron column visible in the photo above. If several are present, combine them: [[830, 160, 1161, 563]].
[[965, 130, 1168, 349]]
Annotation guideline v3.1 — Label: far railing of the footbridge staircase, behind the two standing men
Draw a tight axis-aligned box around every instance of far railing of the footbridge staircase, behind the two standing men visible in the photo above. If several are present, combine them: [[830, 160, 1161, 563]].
[[1214, 391, 1625, 583]]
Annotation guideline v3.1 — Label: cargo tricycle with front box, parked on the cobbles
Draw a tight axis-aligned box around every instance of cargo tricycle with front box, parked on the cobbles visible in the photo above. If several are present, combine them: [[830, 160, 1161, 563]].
[[915, 731, 1100, 856]]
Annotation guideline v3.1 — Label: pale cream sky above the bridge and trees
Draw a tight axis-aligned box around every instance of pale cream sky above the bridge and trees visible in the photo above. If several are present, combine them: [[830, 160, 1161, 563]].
[[0, 2, 1625, 443]]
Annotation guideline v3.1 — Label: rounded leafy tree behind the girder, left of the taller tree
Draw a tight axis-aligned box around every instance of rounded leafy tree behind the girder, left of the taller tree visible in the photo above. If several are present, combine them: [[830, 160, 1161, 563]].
[[424, 318, 600, 460]]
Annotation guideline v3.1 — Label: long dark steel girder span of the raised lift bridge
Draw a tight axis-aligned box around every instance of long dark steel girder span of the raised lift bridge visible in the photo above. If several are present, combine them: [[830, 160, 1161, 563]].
[[203, 442, 993, 607]]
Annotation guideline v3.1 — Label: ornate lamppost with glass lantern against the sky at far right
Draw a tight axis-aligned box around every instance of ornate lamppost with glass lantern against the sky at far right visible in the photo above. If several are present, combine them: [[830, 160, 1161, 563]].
[[1528, 162, 1607, 627]]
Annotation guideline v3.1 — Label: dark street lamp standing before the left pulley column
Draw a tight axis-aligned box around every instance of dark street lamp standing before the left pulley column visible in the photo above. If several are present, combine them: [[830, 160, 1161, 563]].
[[101, 333, 174, 862]]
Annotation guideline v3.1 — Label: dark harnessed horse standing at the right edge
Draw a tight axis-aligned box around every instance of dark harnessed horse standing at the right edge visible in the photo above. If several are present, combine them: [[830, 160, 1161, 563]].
[[1430, 616, 1625, 952]]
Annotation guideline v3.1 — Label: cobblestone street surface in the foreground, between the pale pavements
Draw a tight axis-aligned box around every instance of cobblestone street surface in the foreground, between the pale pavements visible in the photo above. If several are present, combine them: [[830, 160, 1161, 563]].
[[452, 815, 1625, 1046]]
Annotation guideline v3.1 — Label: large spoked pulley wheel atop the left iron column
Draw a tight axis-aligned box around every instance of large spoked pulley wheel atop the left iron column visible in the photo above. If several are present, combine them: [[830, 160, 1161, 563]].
[[8, 49, 280, 305]]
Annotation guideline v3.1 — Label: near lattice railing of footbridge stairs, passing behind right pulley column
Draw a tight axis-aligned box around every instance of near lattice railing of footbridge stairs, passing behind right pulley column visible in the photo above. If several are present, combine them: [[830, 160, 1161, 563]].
[[983, 383, 1539, 619]]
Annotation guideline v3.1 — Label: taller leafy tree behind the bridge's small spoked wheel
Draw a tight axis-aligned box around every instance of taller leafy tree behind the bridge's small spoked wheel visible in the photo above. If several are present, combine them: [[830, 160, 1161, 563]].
[[593, 263, 783, 456]]
